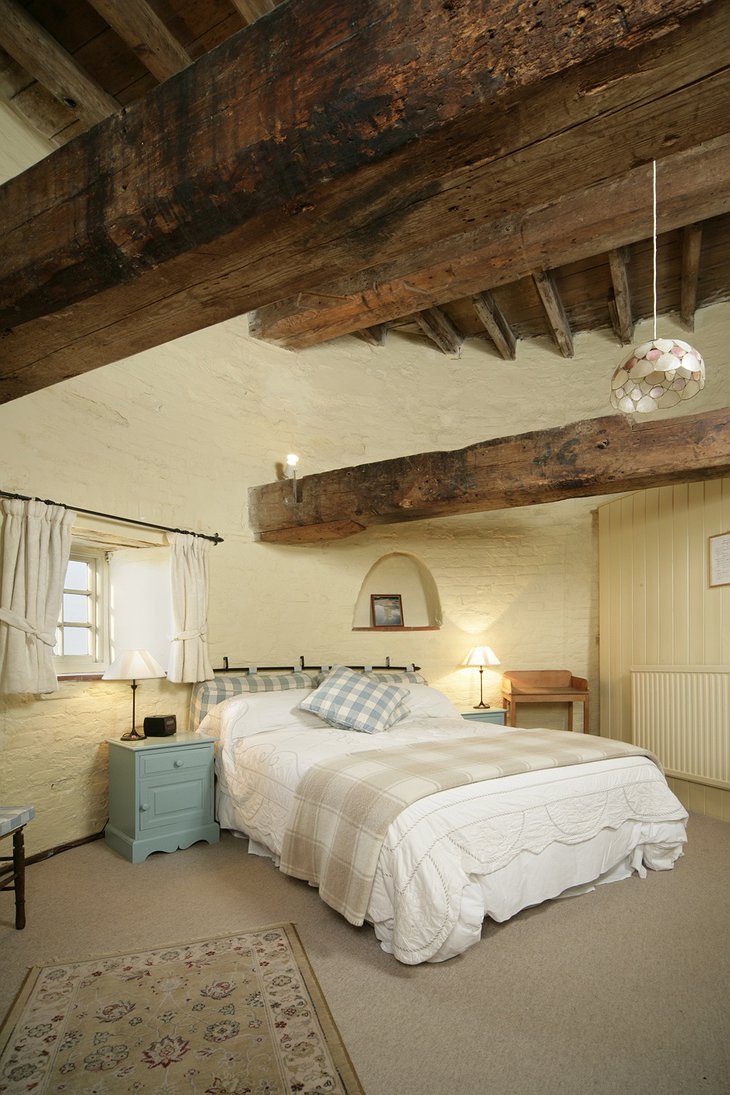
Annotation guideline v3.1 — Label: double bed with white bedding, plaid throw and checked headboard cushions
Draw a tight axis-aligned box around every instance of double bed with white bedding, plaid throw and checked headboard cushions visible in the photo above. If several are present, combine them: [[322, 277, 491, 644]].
[[192, 667, 687, 965]]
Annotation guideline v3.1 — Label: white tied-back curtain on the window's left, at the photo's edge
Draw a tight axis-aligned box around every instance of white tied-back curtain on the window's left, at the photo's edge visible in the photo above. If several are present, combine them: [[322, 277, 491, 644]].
[[0, 498, 76, 694]]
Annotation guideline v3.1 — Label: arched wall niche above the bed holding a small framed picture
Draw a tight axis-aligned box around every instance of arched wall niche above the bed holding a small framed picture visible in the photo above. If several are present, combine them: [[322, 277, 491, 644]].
[[352, 551, 443, 631]]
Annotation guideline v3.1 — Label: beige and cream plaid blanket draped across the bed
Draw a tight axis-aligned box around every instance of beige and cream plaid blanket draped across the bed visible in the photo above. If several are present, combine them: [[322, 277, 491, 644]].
[[279, 730, 661, 924]]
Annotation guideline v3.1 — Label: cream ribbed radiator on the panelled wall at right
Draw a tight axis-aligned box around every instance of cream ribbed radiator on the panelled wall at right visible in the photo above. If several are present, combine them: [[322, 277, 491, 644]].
[[631, 666, 730, 788]]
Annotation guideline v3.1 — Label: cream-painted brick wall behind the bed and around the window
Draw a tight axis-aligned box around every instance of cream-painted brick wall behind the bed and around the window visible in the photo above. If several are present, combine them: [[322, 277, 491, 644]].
[[0, 286, 730, 852]]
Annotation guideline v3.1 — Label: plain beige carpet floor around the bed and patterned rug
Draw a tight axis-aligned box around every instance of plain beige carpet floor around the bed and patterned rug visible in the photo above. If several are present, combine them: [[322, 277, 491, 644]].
[[0, 815, 730, 1095]]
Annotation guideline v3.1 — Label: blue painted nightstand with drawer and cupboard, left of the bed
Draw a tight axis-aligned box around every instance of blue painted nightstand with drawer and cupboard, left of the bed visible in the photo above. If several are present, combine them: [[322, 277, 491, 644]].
[[104, 734, 220, 863]]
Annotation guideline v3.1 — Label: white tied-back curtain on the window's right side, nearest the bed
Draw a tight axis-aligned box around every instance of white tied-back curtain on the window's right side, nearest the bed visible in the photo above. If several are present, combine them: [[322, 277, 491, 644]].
[[167, 532, 213, 683]]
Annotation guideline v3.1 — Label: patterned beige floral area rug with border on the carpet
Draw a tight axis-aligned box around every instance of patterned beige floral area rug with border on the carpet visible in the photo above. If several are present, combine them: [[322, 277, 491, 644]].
[[0, 924, 362, 1095]]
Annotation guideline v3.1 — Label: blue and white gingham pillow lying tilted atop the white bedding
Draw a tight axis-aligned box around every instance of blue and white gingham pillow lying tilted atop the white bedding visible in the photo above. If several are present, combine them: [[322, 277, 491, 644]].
[[299, 666, 408, 734]]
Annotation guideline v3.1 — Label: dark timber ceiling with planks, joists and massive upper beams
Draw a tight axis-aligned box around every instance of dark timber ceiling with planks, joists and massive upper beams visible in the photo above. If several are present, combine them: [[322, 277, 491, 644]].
[[0, 0, 730, 402]]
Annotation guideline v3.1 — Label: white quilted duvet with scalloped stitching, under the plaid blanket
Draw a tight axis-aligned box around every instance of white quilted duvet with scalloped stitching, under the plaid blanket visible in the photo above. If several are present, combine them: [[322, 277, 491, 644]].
[[199, 685, 687, 965]]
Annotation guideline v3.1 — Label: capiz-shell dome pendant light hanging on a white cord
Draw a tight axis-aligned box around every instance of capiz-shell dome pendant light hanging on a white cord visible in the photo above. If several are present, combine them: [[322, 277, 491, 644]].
[[611, 160, 705, 414]]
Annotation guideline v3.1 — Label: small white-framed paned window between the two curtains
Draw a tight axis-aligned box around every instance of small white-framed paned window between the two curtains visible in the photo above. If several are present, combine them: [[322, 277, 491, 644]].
[[54, 548, 109, 676]]
